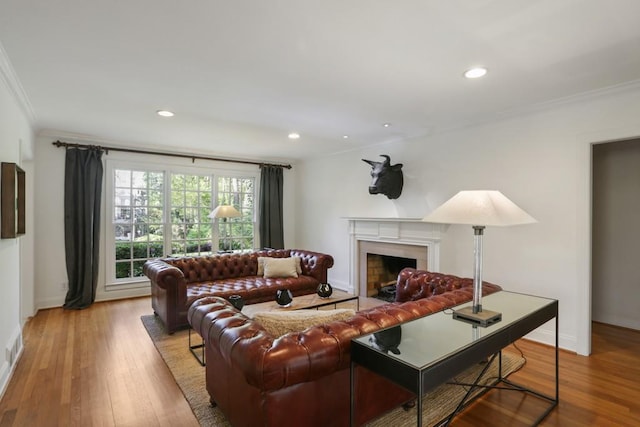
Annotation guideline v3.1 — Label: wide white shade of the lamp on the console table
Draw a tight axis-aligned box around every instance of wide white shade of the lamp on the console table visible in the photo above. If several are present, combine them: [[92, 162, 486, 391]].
[[422, 190, 537, 226]]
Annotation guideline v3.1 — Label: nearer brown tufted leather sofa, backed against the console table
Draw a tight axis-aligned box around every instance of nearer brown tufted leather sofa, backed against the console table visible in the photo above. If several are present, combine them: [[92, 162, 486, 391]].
[[188, 268, 501, 426]]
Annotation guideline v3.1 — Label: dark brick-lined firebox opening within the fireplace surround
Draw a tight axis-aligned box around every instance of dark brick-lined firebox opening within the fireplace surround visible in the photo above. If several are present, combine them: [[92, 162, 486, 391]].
[[367, 253, 417, 302]]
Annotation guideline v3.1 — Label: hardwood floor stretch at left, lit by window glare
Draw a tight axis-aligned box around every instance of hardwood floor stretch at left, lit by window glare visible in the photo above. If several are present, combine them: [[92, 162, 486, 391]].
[[0, 298, 198, 427]]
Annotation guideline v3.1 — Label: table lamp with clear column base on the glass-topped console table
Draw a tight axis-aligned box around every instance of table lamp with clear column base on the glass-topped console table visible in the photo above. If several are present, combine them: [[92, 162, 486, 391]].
[[422, 190, 537, 327]]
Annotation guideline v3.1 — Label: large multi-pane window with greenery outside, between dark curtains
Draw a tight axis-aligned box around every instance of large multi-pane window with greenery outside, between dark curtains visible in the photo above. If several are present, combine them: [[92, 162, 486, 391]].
[[107, 162, 257, 285]]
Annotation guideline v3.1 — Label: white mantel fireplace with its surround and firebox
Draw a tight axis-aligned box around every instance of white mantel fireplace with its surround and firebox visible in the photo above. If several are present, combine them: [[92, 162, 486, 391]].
[[348, 218, 446, 296]]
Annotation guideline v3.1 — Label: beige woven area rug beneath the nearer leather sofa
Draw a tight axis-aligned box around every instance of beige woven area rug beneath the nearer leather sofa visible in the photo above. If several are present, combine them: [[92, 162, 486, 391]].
[[141, 315, 525, 427]]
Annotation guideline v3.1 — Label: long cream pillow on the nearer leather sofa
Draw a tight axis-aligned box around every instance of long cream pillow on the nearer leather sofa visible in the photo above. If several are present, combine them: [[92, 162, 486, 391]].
[[253, 308, 356, 337]]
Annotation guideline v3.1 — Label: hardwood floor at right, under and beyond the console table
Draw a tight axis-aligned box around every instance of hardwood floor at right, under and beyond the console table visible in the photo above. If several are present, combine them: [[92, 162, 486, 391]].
[[452, 322, 640, 427]]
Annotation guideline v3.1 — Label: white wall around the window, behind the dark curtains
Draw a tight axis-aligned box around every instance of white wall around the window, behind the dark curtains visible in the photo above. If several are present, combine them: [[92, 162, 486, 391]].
[[35, 139, 296, 311]]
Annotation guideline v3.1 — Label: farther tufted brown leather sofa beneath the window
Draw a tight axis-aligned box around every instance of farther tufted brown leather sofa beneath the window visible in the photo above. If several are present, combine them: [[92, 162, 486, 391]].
[[142, 249, 333, 334]]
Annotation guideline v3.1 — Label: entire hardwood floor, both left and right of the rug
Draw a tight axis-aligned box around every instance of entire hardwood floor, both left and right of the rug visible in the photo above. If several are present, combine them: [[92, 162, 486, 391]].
[[0, 298, 640, 427]]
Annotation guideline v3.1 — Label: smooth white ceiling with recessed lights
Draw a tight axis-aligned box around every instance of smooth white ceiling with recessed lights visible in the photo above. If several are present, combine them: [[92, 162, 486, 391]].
[[0, 0, 640, 159]]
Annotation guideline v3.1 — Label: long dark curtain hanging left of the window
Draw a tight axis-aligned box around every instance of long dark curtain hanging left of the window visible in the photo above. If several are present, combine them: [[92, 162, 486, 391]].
[[64, 147, 102, 309]]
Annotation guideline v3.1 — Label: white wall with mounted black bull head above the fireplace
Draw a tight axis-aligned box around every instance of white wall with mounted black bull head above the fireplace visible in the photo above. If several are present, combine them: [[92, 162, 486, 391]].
[[296, 85, 640, 354]]
